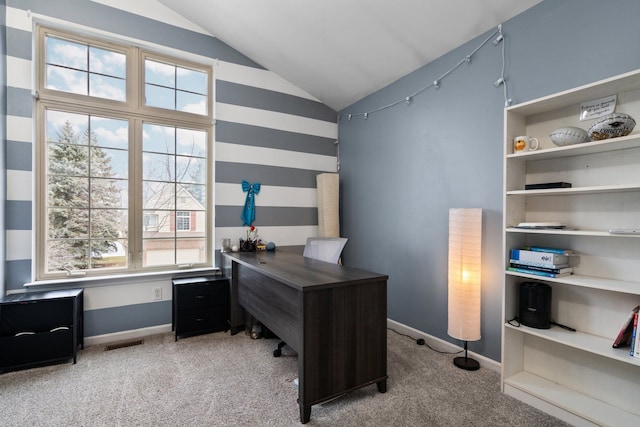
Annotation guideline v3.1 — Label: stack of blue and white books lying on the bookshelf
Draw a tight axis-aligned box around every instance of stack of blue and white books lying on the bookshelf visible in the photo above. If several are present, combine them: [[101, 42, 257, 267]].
[[507, 246, 573, 278]]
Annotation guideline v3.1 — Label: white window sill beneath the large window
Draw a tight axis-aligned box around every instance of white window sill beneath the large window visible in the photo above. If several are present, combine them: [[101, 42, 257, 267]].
[[23, 267, 222, 288]]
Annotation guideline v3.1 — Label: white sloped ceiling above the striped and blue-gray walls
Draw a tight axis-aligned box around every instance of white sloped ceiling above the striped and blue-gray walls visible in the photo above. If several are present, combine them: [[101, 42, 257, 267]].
[[155, 0, 542, 110]]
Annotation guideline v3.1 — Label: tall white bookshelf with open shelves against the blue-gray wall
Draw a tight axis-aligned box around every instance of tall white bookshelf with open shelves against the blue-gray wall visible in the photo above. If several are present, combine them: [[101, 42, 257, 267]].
[[502, 70, 640, 426]]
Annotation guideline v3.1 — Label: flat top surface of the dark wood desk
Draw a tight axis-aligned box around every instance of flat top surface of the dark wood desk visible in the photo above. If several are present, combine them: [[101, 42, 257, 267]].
[[224, 251, 388, 292]]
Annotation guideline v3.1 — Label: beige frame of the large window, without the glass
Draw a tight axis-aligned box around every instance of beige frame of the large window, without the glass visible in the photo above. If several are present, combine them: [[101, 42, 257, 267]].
[[34, 26, 214, 281]]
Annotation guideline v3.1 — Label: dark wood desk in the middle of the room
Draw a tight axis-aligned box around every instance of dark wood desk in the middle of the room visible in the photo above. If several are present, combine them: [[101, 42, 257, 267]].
[[223, 252, 388, 424]]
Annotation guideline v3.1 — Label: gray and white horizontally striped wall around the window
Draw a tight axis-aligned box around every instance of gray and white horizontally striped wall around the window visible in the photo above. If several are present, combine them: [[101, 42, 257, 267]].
[[0, 0, 338, 342]]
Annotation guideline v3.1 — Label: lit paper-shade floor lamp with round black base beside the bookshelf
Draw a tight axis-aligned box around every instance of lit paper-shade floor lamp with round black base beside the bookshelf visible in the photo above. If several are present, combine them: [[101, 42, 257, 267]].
[[447, 208, 482, 371]]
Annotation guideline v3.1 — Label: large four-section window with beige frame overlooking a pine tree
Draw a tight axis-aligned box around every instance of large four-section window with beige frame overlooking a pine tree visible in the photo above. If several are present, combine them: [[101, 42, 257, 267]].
[[36, 28, 212, 280]]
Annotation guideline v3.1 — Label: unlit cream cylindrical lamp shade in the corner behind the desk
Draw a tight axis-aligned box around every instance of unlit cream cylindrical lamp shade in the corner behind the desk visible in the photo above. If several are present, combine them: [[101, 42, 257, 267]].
[[316, 173, 340, 237]]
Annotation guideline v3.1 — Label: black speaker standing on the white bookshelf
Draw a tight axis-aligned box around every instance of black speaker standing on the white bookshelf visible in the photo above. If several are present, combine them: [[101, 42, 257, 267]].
[[520, 282, 551, 329]]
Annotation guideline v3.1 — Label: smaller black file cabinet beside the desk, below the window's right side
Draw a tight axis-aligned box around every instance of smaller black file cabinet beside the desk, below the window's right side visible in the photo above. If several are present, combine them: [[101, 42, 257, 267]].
[[172, 276, 229, 341]]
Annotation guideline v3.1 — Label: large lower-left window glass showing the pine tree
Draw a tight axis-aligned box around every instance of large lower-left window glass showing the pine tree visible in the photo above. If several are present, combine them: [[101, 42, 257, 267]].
[[45, 110, 128, 271]]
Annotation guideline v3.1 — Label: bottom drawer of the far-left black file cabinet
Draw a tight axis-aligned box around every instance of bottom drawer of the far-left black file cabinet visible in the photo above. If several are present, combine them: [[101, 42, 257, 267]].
[[0, 328, 73, 369]]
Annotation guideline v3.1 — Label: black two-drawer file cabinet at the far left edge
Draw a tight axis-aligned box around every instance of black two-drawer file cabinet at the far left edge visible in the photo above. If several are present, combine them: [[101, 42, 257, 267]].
[[0, 289, 84, 372]]
